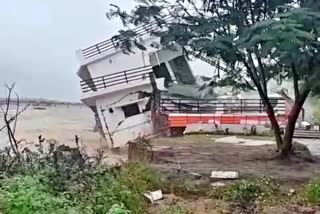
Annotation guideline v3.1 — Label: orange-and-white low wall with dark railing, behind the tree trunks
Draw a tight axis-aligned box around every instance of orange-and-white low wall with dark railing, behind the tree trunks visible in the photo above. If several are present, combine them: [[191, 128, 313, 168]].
[[160, 99, 287, 128]]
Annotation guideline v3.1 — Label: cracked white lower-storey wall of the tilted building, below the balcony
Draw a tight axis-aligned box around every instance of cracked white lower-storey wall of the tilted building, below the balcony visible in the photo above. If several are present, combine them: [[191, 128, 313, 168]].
[[96, 85, 153, 147]]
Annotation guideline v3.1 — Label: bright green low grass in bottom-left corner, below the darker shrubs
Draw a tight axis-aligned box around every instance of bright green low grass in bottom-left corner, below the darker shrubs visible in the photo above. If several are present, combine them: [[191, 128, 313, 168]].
[[0, 163, 161, 214]]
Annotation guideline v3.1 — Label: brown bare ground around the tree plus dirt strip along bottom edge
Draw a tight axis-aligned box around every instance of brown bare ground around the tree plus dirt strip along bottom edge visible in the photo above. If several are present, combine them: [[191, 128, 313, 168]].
[[150, 135, 320, 214]]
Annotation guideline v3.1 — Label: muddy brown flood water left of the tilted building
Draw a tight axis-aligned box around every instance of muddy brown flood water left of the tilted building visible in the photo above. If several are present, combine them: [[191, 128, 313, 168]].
[[0, 105, 105, 151]]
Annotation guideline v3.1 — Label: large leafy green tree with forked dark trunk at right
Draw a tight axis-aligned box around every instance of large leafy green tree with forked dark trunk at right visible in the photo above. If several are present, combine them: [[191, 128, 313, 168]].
[[107, 0, 320, 157]]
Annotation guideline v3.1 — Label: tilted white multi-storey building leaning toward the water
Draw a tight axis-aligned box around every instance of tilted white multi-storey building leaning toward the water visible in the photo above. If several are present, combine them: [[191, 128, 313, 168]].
[[77, 21, 208, 147]]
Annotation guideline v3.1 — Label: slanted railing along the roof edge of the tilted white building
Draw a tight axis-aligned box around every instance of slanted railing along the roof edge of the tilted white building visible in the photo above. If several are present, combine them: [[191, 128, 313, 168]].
[[81, 16, 173, 59]]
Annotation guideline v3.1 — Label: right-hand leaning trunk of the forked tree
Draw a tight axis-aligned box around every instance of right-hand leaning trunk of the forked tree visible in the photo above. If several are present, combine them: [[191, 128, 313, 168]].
[[281, 89, 310, 157]]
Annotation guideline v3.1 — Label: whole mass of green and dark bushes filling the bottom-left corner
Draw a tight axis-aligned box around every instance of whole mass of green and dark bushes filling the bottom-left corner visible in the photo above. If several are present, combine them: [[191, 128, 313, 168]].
[[0, 140, 161, 214]]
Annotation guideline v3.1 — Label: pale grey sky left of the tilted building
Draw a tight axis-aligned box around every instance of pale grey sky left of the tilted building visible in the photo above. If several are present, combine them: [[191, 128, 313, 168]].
[[0, 0, 134, 101]]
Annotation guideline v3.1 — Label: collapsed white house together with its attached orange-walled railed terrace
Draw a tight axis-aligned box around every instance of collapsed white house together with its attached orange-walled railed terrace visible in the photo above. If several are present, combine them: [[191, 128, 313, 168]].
[[77, 20, 285, 147]]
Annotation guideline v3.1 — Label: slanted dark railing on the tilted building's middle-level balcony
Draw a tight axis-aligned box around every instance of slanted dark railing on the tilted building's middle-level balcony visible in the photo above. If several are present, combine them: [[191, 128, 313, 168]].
[[81, 66, 152, 93]]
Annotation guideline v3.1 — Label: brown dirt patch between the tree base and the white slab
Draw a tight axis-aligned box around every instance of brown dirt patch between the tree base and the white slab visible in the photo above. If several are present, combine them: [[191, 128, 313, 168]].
[[152, 135, 320, 183]]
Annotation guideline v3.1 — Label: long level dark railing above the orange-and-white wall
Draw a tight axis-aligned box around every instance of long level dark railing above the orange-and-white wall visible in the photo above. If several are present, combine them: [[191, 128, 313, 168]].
[[160, 99, 286, 114]]
